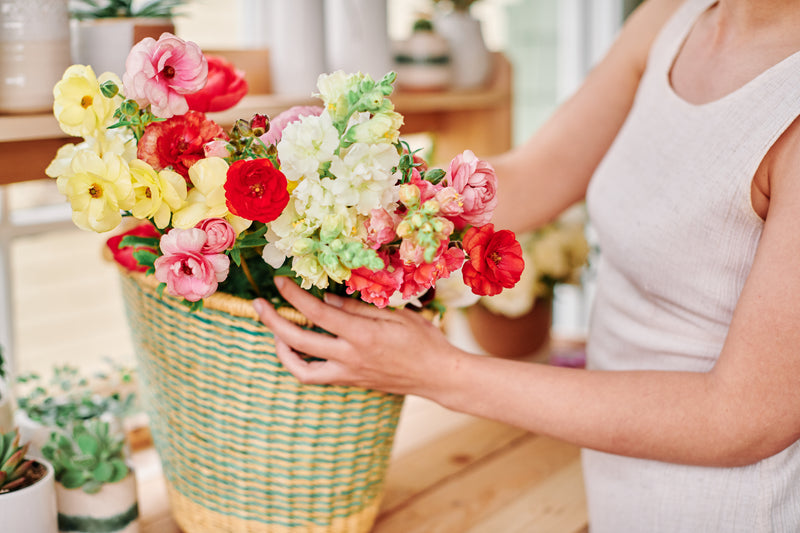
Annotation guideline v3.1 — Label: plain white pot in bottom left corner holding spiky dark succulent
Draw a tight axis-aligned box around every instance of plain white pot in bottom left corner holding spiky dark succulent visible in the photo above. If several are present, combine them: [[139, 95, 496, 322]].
[[0, 458, 58, 533]]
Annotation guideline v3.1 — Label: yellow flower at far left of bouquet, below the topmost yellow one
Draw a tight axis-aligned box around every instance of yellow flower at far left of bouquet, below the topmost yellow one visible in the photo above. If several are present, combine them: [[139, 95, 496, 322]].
[[56, 150, 134, 233]]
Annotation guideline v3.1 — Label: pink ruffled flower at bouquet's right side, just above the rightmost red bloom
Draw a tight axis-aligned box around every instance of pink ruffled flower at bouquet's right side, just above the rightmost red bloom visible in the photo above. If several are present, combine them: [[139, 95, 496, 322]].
[[448, 150, 497, 229]]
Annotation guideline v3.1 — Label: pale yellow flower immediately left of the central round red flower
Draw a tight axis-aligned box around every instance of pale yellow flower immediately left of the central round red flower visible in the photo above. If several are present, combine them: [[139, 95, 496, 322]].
[[172, 157, 252, 235]]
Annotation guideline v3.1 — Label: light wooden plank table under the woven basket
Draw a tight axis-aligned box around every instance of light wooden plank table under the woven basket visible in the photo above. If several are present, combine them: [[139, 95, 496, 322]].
[[137, 397, 587, 533]]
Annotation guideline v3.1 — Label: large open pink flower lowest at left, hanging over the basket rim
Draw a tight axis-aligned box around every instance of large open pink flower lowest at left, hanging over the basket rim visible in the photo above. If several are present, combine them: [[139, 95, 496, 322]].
[[155, 228, 230, 302]]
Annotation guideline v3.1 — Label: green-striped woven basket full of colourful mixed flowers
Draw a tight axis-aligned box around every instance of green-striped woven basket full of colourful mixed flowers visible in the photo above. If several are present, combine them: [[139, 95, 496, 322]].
[[47, 34, 523, 532]]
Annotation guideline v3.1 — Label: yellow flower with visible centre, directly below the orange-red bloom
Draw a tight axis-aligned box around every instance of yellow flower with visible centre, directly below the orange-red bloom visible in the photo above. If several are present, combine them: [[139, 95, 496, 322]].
[[130, 159, 186, 229]]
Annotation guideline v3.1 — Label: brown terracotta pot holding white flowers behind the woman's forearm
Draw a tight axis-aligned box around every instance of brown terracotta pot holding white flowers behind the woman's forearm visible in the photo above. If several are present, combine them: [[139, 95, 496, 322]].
[[466, 299, 553, 360]]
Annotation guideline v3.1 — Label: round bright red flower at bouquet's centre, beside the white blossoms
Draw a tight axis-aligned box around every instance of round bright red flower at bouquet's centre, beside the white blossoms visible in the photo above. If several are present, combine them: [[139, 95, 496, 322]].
[[225, 159, 289, 224]]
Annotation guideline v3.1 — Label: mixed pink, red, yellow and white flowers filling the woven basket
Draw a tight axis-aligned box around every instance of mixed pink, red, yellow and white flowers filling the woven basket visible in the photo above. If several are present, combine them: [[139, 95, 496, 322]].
[[47, 34, 523, 316]]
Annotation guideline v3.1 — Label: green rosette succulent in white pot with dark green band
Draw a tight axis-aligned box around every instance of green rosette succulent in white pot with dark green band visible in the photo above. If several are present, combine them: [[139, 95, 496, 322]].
[[42, 419, 139, 533]]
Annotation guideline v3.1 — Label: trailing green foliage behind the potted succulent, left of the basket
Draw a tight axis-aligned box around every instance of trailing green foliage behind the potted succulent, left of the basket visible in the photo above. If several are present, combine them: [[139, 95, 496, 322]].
[[17, 361, 137, 429]]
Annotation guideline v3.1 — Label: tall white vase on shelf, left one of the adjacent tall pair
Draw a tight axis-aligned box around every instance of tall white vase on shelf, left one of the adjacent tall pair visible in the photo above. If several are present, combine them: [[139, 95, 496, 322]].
[[268, 0, 325, 96]]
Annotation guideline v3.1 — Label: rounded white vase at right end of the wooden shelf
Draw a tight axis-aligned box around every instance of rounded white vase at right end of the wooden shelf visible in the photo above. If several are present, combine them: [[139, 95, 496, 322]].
[[434, 11, 492, 89]]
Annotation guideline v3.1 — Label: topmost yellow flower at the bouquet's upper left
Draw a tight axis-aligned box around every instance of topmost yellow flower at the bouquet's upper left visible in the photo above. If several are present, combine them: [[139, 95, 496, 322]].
[[53, 65, 122, 137]]
